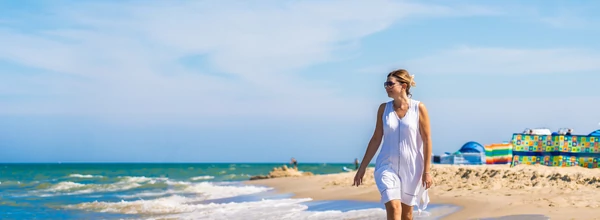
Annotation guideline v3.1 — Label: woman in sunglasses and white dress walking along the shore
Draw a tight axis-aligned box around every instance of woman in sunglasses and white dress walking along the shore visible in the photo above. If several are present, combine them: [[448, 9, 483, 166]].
[[353, 69, 433, 219]]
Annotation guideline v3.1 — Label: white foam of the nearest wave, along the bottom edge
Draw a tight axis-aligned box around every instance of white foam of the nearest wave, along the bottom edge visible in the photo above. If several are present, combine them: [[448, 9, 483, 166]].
[[71, 196, 385, 220]]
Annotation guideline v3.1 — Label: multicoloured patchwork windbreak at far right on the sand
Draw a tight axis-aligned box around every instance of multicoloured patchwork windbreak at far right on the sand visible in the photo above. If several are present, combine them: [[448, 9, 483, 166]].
[[511, 130, 600, 168]]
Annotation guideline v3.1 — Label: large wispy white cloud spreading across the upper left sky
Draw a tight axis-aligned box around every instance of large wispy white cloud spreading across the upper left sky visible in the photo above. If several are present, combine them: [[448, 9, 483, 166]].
[[0, 0, 495, 124]]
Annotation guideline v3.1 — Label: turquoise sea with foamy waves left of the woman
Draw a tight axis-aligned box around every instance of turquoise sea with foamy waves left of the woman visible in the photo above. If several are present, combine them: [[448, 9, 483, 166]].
[[0, 163, 460, 219]]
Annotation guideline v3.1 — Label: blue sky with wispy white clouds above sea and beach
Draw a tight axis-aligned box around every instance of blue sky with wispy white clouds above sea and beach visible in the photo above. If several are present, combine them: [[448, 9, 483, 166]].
[[0, 0, 600, 162]]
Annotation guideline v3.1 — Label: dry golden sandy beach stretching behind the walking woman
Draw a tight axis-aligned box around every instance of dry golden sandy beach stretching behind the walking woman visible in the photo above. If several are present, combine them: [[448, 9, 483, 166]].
[[247, 164, 600, 219]]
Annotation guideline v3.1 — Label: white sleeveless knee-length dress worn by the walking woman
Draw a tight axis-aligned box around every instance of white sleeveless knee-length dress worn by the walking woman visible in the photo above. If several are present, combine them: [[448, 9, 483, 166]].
[[375, 99, 429, 211]]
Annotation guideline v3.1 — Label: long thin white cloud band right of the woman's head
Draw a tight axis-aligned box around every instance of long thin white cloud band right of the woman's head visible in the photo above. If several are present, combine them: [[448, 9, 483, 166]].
[[376, 46, 600, 75]]
